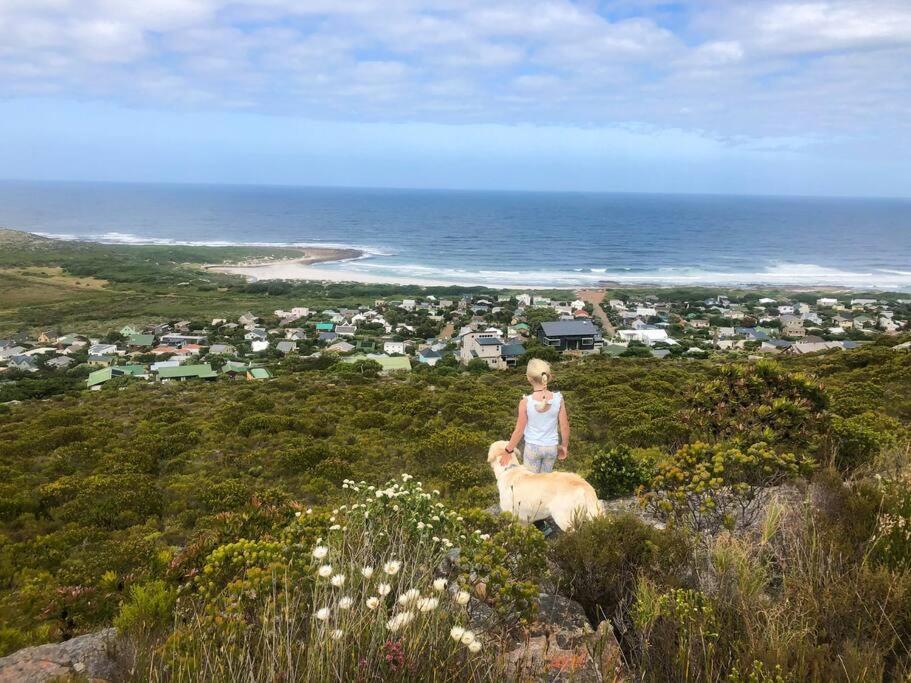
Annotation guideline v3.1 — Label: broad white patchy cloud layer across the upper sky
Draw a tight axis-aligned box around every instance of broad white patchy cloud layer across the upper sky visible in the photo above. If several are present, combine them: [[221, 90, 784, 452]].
[[0, 0, 911, 149]]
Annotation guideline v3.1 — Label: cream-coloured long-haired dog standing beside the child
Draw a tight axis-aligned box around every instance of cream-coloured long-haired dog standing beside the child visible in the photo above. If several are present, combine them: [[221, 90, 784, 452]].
[[487, 441, 603, 531]]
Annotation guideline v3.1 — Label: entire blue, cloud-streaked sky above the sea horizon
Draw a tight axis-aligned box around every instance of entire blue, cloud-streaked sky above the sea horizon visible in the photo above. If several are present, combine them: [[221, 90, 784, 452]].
[[0, 0, 911, 197]]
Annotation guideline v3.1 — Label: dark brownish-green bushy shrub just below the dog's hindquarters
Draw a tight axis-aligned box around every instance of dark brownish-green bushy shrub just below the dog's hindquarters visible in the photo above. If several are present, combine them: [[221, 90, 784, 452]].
[[550, 514, 690, 623]]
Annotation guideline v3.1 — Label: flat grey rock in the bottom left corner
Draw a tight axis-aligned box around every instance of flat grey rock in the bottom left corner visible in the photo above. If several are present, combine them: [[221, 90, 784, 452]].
[[0, 628, 128, 683]]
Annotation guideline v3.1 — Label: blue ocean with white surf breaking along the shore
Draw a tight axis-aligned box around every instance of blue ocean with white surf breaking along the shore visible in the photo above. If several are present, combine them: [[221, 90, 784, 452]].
[[0, 182, 911, 290]]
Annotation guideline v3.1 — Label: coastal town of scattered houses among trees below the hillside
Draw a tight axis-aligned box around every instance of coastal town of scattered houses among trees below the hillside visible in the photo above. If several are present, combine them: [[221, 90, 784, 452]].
[[0, 290, 911, 390]]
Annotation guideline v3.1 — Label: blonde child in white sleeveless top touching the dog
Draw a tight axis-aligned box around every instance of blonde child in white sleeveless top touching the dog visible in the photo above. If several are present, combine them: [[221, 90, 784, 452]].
[[502, 358, 569, 472]]
